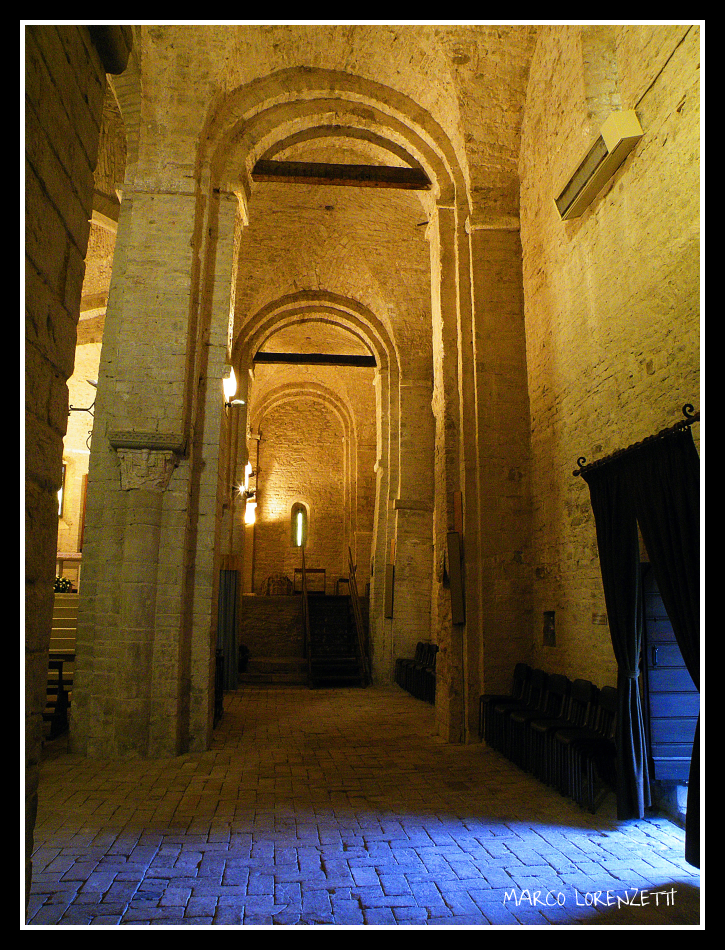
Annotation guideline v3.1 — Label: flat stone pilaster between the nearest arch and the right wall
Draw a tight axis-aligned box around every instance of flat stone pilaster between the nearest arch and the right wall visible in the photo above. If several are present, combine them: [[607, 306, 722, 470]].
[[468, 216, 532, 704]]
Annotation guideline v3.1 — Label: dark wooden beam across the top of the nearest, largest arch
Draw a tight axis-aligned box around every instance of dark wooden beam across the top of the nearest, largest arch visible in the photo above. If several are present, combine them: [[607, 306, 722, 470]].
[[252, 159, 430, 191]]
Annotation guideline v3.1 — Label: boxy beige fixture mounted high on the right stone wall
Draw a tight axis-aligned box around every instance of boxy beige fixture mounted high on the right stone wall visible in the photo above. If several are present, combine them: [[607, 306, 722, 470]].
[[556, 109, 643, 221]]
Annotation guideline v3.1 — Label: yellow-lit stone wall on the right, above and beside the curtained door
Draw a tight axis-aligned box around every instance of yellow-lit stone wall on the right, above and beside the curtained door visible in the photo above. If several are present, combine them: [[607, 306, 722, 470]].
[[520, 26, 700, 685]]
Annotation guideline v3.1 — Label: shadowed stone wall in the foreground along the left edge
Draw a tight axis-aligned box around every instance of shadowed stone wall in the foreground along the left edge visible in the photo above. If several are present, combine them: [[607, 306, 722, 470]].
[[25, 20, 130, 916]]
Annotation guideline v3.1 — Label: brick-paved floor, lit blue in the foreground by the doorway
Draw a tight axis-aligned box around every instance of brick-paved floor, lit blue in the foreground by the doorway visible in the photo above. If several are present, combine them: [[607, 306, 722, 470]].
[[28, 687, 701, 927]]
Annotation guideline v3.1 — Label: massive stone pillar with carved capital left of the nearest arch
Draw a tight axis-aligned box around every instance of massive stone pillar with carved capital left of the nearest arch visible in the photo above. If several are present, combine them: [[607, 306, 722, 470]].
[[71, 167, 238, 756]]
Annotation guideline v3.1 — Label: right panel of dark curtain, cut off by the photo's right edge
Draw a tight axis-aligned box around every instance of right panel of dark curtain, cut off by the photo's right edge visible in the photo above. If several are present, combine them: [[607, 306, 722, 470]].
[[627, 428, 700, 867]]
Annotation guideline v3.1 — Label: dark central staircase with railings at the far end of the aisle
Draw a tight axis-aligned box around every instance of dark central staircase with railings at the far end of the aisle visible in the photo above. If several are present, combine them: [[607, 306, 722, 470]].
[[308, 594, 367, 688]]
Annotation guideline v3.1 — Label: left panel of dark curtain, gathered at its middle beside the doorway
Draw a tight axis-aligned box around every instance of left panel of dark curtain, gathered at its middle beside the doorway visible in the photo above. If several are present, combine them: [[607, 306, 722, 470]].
[[582, 460, 651, 819]]
